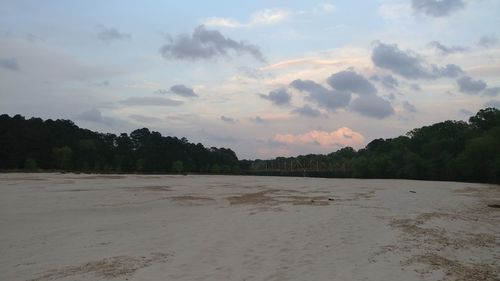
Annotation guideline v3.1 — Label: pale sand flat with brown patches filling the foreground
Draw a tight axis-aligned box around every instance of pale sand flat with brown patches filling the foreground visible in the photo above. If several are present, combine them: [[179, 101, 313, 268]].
[[0, 174, 500, 281]]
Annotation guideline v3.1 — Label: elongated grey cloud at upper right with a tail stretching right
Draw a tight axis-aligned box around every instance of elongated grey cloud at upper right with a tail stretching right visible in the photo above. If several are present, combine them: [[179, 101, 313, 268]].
[[371, 42, 463, 79]]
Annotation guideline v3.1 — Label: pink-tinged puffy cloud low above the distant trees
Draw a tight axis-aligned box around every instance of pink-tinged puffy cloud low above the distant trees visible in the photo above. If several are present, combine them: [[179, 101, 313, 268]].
[[274, 127, 365, 147]]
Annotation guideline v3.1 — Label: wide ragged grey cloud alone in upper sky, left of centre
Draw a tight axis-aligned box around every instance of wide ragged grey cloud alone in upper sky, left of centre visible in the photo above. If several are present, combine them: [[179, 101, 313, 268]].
[[160, 25, 265, 62]]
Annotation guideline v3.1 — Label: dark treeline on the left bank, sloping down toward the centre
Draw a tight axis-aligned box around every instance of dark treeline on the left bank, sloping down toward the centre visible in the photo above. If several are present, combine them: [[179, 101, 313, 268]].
[[0, 114, 239, 173]]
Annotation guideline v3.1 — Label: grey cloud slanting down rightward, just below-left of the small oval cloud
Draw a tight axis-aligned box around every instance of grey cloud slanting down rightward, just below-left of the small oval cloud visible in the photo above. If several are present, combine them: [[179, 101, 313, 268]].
[[290, 79, 351, 112]]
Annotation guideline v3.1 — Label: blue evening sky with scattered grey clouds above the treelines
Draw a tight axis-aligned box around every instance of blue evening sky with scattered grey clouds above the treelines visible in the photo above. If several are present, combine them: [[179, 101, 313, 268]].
[[0, 0, 500, 159]]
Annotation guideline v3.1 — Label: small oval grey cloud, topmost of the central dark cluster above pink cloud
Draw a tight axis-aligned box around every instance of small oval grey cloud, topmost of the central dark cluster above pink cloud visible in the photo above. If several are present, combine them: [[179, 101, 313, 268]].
[[327, 70, 377, 95]]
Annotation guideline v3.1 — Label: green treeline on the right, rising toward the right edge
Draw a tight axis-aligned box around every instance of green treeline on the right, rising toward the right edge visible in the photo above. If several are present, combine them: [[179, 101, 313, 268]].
[[240, 108, 500, 183]]
